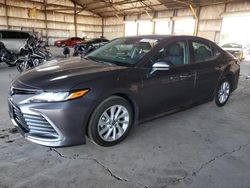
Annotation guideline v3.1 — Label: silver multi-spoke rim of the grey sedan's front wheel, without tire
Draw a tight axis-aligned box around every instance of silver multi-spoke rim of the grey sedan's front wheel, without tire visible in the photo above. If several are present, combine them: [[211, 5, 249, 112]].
[[98, 105, 130, 142]]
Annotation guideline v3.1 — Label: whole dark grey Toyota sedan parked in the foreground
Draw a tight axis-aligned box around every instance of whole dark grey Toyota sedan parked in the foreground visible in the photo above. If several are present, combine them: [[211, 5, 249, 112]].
[[8, 35, 240, 146]]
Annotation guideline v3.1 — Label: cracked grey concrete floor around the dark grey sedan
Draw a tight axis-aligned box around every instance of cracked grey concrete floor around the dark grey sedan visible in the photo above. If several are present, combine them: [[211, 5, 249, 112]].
[[0, 49, 250, 188]]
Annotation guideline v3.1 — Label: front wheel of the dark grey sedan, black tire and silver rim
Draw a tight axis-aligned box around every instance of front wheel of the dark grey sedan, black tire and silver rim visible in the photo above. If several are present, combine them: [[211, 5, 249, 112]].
[[88, 96, 133, 147]]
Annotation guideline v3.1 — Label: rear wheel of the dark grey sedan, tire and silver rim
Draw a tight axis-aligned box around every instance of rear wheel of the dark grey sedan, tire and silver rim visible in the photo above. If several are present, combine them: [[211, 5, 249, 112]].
[[214, 78, 231, 107]]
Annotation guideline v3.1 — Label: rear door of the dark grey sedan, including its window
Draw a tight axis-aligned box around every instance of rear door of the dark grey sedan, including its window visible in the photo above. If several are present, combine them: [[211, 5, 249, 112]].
[[189, 40, 223, 101]]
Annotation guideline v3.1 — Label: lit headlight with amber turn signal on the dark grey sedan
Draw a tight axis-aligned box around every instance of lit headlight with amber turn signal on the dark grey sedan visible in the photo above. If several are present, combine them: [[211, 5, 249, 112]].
[[21, 89, 89, 104]]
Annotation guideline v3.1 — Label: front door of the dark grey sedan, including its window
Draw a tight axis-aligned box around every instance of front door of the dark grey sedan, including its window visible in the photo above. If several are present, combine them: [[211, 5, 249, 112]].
[[141, 41, 195, 119]]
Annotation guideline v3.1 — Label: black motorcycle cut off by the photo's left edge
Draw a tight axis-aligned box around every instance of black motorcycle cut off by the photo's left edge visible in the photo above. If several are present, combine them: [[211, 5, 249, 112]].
[[0, 42, 17, 67]]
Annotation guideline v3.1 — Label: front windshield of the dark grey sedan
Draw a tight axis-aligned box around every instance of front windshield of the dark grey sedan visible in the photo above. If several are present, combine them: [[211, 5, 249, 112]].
[[87, 38, 158, 66]]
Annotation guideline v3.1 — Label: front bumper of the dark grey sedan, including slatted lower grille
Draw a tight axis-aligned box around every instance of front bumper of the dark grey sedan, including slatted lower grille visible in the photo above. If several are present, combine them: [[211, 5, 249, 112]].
[[8, 97, 94, 147]]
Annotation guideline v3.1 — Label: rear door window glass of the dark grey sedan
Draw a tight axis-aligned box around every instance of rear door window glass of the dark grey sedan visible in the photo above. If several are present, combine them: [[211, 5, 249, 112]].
[[192, 41, 214, 63]]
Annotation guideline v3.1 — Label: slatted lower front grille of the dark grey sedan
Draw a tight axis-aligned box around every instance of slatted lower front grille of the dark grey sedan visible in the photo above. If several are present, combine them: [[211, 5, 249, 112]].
[[10, 102, 59, 139]]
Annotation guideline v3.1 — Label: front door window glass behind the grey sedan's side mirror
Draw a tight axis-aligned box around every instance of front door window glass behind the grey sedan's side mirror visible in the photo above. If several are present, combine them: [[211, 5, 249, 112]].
[[151, 41, 189, 66]]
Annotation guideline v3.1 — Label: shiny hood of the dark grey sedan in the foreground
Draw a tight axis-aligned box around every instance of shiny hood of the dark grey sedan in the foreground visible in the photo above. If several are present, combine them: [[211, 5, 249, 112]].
[[12, 57, 127, 91]]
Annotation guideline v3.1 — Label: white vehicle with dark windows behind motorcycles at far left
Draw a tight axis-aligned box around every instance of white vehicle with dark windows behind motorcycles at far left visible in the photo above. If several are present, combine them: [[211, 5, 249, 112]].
[[0, 30, 32, 54]]
